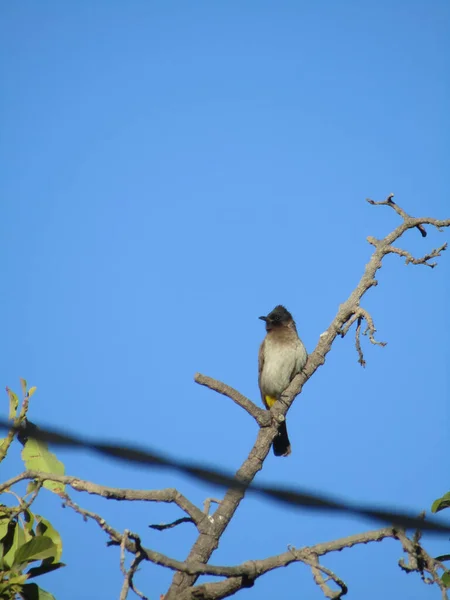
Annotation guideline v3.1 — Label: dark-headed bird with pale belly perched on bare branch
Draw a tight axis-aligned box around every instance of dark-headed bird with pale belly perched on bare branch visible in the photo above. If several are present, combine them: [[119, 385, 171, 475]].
[[258, 305, 308, 456]]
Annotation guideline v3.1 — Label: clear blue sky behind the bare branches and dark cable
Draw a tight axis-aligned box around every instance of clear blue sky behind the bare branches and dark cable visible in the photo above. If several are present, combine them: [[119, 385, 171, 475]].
[[0, 0, 450, 600]]
